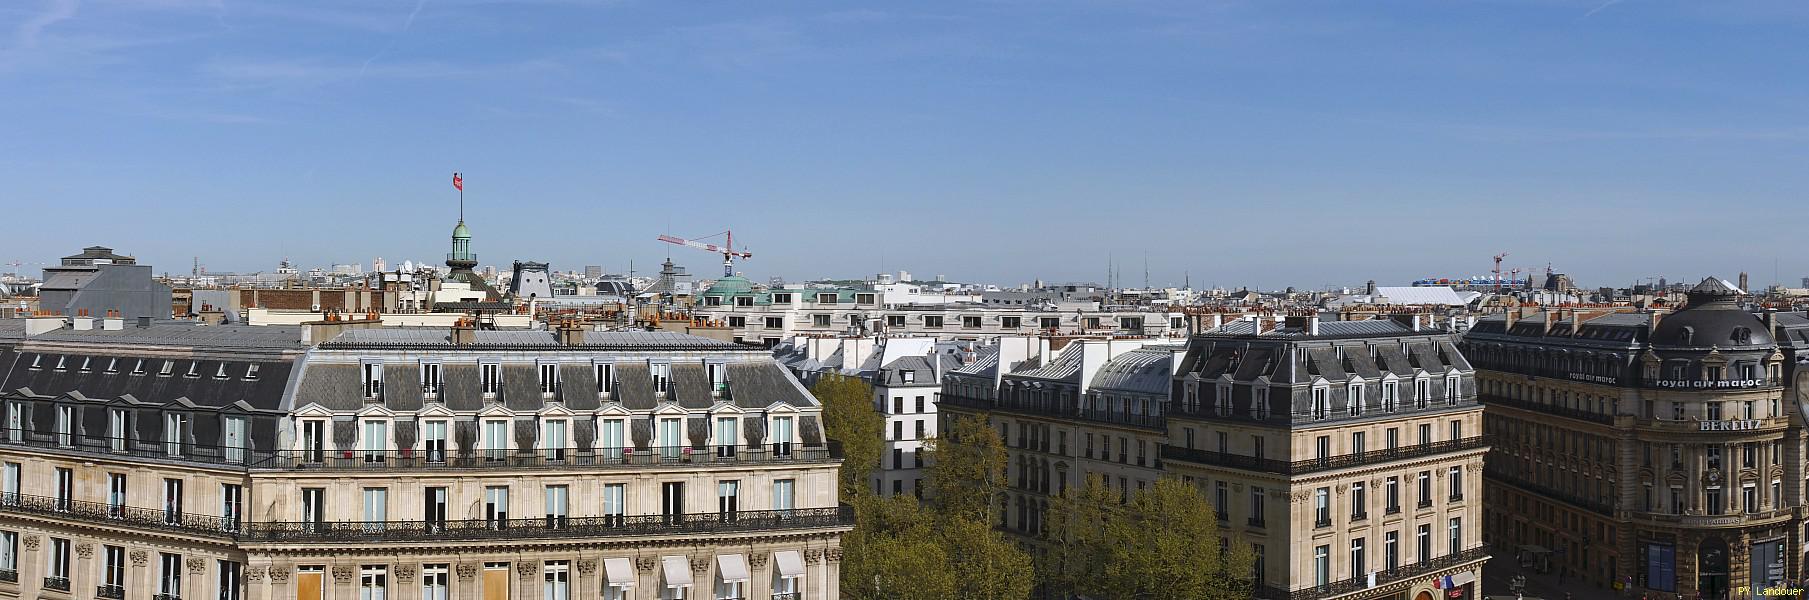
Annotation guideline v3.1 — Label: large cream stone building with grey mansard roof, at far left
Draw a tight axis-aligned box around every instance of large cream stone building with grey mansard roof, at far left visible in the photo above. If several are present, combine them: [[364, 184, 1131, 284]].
[[0, 316, 852, 600]]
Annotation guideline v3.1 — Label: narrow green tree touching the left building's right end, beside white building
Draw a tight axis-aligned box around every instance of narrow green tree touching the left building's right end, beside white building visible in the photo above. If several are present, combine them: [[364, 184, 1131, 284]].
[[810, 372, 886, 499]]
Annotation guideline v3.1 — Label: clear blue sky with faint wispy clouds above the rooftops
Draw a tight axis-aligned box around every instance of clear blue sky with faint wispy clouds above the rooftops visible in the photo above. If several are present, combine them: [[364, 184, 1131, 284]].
[[0, 0, 1809, 287]]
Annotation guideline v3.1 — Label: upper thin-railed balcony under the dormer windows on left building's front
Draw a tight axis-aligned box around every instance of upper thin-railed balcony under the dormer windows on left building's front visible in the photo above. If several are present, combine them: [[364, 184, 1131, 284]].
[[251, 445, 841, 472]]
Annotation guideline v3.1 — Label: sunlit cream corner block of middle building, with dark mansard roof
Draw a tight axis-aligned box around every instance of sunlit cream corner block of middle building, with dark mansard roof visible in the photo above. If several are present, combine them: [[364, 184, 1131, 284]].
[[1163, 314, 1489, 600]]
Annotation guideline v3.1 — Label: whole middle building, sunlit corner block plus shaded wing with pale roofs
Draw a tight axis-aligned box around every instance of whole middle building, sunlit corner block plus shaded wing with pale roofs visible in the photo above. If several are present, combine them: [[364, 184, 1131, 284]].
[[939, 321, 1489, 600]]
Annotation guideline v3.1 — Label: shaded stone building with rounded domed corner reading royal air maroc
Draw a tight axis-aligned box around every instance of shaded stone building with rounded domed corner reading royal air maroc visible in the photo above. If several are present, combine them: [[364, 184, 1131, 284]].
[[1462, 278, 1804, 598]]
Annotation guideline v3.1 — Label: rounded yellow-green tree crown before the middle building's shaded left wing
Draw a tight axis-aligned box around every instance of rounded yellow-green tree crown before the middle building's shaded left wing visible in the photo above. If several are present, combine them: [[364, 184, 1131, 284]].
[[924, 414, 1006, 522]]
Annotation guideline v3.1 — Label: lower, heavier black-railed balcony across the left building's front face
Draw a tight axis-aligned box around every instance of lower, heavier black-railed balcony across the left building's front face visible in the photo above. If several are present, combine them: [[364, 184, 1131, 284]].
[[239, 504, 854, 544]]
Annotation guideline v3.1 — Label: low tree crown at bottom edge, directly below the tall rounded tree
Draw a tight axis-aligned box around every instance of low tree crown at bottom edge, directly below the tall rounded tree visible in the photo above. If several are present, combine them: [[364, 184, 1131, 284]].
[[942, 517, 1037, 600]]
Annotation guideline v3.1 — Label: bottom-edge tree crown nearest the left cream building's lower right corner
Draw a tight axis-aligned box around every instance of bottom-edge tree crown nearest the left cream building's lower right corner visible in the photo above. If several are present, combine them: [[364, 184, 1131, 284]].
[[841, 493, 955, 600]]
